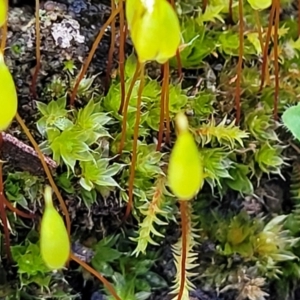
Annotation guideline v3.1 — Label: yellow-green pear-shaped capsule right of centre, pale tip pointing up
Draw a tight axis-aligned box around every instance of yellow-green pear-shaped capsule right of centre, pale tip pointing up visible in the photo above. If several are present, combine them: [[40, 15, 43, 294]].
[[168, 113, 204, 200]]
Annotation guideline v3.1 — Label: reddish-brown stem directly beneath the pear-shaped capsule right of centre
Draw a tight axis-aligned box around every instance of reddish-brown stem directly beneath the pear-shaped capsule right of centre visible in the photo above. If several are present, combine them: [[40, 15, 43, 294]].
[[177, 201, 187, 300]]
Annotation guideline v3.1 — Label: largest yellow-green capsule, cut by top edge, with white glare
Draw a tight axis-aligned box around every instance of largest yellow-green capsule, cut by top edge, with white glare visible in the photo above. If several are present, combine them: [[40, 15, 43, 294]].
[[126, 0, 180, 64]]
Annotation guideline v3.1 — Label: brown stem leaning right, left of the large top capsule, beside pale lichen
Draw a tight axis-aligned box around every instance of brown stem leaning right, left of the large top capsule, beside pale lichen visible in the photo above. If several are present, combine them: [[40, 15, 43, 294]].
[[70, 5, 121, 106]]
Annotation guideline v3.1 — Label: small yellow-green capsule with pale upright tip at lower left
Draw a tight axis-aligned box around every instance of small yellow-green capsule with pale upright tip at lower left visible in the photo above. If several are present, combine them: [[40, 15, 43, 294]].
[[40, 186, 70, 270]]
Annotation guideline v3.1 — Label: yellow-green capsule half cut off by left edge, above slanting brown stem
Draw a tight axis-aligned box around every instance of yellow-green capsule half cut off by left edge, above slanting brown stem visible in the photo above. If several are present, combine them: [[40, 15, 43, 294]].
[[0, 51, 18, 132]]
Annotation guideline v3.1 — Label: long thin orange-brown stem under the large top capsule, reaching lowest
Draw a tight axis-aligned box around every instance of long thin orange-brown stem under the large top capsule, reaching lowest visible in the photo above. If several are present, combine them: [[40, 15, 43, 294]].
[[124, 63, 145, 220]]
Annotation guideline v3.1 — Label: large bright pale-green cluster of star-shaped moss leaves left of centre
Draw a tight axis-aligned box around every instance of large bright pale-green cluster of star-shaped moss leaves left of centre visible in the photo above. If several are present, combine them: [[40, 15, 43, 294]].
[[37, 97, 111, 173]]
